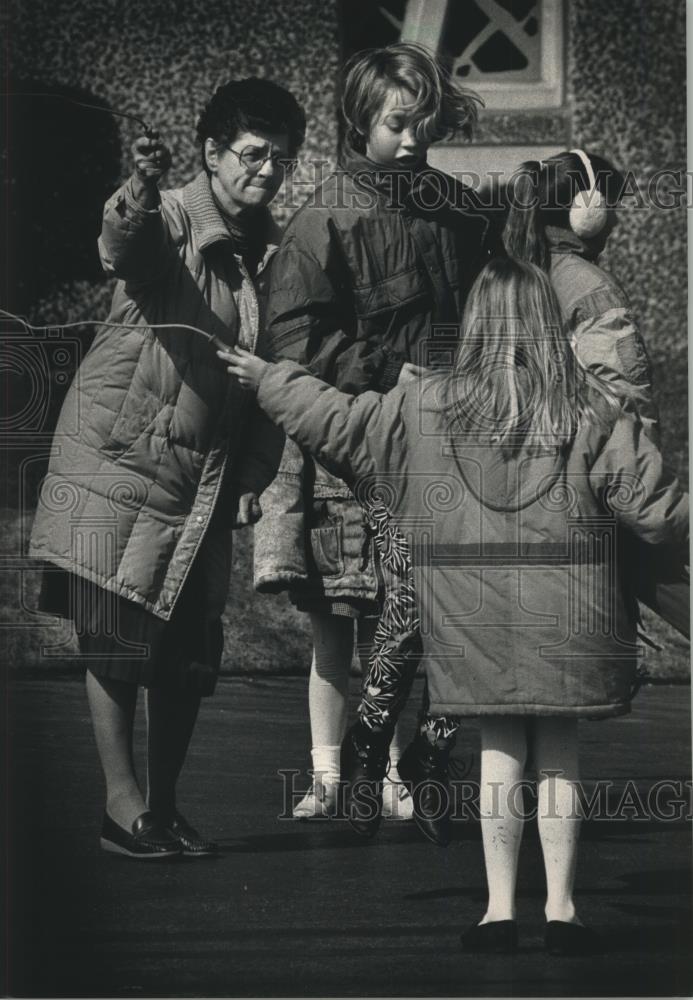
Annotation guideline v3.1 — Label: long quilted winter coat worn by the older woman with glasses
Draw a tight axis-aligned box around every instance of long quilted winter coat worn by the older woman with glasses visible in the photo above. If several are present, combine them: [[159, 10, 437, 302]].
[[30, 173, 283, 619]]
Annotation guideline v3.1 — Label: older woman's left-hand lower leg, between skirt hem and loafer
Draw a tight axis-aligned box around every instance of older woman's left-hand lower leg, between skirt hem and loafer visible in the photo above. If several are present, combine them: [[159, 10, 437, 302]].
[[87, 670, 146, 832]]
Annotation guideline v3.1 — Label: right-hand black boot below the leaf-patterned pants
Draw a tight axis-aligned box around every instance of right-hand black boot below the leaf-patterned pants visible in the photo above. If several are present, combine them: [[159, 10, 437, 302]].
[[397, 733, 454, 848]]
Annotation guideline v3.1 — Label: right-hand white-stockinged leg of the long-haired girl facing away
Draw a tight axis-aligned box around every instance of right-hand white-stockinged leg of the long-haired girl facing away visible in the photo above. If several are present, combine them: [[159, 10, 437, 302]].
[[534, 717, 580, 923]]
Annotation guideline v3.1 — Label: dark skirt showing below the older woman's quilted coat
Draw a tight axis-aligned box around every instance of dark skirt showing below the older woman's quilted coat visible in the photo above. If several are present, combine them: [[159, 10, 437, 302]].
[[38, 533, 230, 695]]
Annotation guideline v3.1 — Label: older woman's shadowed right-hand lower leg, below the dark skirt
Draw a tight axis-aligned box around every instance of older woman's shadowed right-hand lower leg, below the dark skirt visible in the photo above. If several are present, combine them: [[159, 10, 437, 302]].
[[146, 688, 200, 817]]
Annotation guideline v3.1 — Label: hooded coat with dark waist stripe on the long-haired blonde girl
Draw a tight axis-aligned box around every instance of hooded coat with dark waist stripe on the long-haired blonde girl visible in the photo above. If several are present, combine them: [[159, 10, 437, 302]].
[[253, 362, 688, 717]]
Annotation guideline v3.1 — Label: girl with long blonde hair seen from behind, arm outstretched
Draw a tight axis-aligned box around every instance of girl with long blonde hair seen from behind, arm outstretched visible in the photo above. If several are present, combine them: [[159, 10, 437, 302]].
[[222, 259, 688, 954]]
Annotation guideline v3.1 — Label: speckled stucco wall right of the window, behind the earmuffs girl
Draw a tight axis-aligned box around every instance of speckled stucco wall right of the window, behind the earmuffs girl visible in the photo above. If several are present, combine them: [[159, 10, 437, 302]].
[[567, 0, 687, 472]]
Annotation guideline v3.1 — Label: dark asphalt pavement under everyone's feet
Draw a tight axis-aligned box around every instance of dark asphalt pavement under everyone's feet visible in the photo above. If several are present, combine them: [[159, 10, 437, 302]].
[[4, 673, 693, 997]]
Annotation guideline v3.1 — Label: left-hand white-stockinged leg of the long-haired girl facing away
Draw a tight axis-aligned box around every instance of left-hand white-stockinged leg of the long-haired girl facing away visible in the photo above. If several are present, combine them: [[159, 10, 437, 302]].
[[479, 716, 527, 924]]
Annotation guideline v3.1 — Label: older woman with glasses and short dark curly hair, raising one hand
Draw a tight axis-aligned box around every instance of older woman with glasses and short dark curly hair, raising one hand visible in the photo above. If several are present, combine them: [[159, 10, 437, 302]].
[[31, 79, 305, 859]]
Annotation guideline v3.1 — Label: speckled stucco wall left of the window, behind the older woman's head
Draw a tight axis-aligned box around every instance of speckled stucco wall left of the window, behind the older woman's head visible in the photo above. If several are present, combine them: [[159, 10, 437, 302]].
[[3, 0, 339, 321]]
